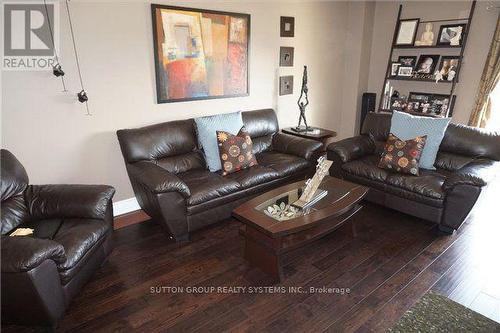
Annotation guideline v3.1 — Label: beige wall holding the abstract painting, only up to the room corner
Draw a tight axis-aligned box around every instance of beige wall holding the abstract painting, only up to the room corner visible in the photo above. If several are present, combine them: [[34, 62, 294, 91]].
[[2, 0, 360, 200]]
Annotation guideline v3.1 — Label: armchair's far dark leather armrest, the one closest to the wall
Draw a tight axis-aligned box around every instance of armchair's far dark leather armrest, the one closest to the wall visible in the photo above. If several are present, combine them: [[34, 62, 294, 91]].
[[25, 185, 115, 219]]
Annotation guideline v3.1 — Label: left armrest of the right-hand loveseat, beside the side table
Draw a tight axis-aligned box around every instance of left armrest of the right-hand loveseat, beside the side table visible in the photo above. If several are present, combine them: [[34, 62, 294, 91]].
[[327, 135, 375, 163]]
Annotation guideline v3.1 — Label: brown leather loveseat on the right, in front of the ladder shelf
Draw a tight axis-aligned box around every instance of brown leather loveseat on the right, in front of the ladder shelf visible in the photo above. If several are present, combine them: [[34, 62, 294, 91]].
[[327, 113, 500, 233]]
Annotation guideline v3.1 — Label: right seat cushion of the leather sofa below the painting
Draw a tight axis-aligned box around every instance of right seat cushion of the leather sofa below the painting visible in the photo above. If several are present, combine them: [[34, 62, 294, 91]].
[[256, 152, 310, 177]]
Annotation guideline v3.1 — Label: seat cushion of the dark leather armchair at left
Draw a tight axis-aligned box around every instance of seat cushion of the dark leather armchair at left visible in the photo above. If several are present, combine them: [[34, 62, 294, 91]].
[[54, 219, 112, 283]]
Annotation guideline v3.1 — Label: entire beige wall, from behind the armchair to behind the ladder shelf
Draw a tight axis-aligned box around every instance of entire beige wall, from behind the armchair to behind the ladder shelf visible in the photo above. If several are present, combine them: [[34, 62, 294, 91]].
[[1, 0, 496, 201]]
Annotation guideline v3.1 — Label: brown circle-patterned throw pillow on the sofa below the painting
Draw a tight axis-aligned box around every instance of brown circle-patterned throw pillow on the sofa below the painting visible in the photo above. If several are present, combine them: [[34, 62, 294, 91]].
[[217, 126, 257, 176]]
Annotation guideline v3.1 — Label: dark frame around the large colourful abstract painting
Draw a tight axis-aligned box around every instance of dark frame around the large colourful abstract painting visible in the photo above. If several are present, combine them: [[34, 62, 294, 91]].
[[151, 3, 251, 104]]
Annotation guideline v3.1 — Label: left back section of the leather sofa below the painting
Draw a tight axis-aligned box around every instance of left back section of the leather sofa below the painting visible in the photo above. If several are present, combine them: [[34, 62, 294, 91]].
[[116, 119, 205, 173]]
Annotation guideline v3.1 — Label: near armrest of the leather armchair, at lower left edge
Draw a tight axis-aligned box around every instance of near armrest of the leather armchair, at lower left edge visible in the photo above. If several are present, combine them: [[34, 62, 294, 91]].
[[2, 236, 66, 273]]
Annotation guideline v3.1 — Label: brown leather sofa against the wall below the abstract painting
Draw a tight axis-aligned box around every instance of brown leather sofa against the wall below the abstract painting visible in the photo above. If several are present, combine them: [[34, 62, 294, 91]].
[[117, 109, 322, 241]]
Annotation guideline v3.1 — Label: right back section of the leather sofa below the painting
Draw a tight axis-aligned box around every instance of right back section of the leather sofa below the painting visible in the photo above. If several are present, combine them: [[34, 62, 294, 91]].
[[241, 109, 279, 154]]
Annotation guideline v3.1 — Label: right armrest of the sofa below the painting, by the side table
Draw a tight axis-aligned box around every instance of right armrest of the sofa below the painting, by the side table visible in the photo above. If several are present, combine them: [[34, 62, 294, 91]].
[[273, 133, 323, 160]]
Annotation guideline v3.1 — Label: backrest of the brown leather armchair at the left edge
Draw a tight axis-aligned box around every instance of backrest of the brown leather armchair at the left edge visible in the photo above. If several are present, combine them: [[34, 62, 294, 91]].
[[0, 149, 29, 235]]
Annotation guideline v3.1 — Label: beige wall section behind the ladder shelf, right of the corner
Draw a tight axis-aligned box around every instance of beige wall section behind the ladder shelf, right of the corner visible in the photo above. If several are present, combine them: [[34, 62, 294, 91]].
[[368, 1, 498, 124]]
